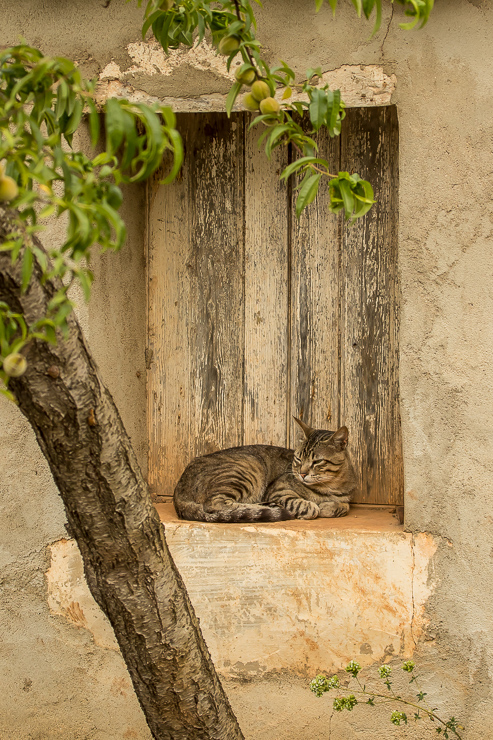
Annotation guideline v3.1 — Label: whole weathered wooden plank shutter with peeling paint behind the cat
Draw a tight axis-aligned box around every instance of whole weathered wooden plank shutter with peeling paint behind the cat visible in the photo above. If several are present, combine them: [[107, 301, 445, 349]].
[[148, 106, 403, 504]]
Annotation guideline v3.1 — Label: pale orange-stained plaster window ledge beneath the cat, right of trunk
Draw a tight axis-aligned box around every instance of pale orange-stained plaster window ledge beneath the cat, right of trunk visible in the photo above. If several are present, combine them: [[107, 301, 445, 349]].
[[156, 504, 436, 679]]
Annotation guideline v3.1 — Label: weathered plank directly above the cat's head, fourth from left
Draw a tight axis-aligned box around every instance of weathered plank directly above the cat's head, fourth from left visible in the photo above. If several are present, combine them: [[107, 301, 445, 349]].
[[288, 125, 340, 445]]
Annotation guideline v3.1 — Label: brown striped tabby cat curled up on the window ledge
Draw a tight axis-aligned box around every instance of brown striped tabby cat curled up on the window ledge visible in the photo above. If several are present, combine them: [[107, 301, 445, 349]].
[[174, 418, 356, 522]]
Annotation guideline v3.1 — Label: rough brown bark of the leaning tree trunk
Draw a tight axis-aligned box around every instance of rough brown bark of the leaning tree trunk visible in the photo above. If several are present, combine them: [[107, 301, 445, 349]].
[[0, 208, 243, 740]]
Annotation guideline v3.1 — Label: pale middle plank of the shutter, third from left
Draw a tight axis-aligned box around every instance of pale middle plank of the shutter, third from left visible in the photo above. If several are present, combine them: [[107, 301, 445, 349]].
[[243, 125, 289, 446]]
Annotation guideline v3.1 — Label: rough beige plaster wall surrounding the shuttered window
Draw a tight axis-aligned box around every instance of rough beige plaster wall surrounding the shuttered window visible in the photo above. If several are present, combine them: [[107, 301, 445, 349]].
[[0, 0, 493, 740]]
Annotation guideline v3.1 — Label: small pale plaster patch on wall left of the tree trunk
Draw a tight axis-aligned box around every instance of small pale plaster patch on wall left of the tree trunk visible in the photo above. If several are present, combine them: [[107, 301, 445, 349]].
[[46, 539, 119, 650]]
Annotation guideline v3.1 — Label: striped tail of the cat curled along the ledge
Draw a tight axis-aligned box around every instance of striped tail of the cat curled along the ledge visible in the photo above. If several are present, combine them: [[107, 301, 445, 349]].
[[175, 501, 293, 524]]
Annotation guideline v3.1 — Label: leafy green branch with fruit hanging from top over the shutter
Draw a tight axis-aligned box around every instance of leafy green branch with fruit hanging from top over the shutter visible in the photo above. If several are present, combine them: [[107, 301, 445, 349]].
[[139, 0, 433, 221]]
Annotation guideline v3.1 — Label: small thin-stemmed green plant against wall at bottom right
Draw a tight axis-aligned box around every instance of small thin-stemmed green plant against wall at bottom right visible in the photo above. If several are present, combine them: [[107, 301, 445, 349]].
[[310, 660, 465, 740]]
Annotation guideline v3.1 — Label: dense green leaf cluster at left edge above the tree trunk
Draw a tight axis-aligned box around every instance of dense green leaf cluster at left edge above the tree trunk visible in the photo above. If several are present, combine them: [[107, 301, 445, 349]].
[[0, 45, 183, 395]]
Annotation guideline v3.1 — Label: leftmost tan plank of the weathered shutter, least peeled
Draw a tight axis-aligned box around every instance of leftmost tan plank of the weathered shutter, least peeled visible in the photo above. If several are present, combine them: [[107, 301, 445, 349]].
[[147, 116, 191, 500]]
